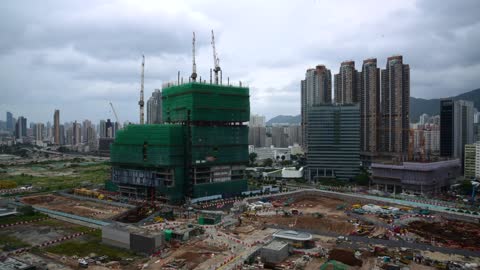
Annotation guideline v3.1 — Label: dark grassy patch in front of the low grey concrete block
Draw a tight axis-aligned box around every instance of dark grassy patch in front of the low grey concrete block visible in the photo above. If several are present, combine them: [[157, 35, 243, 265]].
[[46, 237, 136, 260]]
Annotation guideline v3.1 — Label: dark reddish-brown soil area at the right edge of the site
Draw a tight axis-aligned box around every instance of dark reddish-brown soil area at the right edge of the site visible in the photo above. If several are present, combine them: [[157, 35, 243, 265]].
[[407, 221, 480, 250]]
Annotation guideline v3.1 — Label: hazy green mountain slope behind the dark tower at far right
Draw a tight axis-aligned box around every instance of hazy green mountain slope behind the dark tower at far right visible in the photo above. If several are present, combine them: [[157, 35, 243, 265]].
[[410, 88, 480, 123]]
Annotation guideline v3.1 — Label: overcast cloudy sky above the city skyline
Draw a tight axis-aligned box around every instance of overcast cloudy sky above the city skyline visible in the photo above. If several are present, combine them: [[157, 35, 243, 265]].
[[0, 0, 480, 122]]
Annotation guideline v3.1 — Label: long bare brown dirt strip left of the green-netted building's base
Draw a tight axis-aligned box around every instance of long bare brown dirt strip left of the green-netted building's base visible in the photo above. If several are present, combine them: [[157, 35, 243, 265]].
[[22, 194, 128, 219]]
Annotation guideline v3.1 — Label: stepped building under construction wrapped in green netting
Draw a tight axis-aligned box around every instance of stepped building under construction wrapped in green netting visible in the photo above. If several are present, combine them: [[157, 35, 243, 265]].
[[110, 82, 250, 201]]
